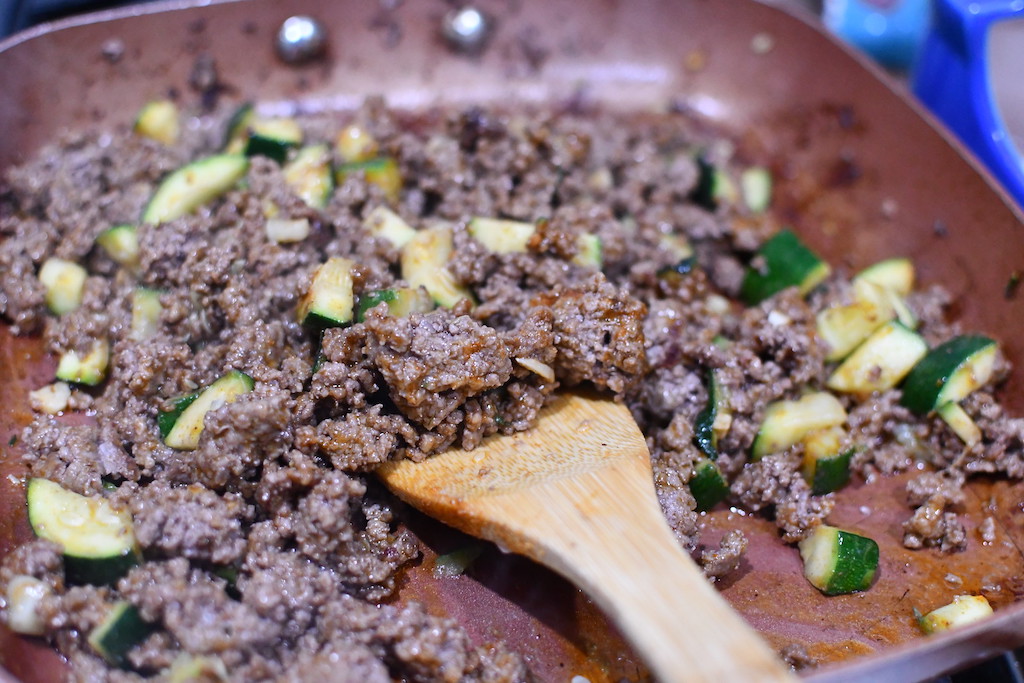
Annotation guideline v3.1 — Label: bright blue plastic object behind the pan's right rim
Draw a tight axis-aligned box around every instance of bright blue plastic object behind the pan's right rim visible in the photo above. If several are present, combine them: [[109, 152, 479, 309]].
[[912, 0, 1024, 208]]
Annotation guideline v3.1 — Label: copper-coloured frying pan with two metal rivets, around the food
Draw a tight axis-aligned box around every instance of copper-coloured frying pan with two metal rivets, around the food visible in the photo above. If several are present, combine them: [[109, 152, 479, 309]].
[[0, 0, 1024, 683]]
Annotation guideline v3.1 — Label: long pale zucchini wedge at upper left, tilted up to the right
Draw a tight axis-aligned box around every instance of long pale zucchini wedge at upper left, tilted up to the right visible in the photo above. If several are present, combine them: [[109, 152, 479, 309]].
[[142, 155, 249, 224]]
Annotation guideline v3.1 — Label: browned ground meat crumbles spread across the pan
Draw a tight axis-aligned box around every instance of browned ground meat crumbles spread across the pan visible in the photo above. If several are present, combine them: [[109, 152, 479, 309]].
[[0, 92, 1024, 682]]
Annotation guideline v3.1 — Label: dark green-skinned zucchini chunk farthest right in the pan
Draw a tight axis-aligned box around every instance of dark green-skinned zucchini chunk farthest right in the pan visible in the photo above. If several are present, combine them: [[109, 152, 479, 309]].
[[900, 335, 998, 415]]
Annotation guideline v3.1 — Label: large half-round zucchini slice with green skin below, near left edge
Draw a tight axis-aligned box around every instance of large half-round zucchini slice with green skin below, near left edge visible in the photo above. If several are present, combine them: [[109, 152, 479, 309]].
[[26, 478, 138, 585]]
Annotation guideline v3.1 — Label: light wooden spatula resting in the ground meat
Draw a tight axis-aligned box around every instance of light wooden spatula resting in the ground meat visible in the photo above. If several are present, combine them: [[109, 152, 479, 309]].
[[377, 394, 796, 683]]
